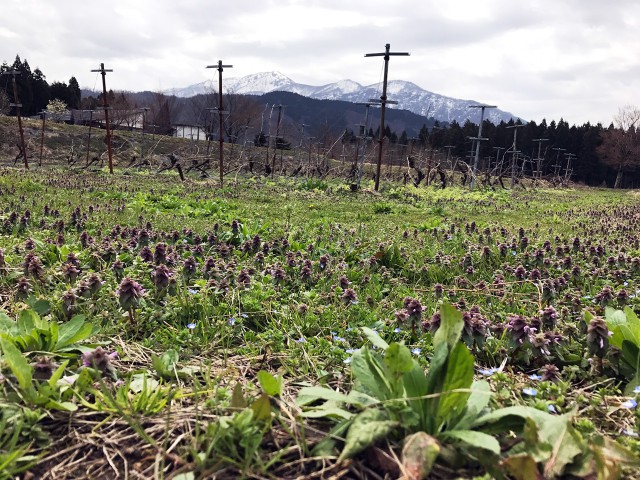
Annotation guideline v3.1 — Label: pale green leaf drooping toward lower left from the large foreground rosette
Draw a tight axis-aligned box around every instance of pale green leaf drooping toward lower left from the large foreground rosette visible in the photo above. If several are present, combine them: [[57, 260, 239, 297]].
[[338, 409, 400, 461]]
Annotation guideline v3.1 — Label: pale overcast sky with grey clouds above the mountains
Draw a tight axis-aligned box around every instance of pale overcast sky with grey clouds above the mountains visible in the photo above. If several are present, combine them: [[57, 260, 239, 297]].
[[0, 0, 640, 124]]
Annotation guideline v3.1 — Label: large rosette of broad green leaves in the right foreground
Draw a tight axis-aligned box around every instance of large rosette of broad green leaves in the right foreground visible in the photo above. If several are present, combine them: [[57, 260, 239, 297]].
[[297, 305, 638, 479]]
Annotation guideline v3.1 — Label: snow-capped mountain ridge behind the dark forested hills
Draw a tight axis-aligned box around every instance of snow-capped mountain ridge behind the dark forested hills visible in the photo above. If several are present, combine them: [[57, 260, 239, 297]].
[[169, 72, 519, 124]]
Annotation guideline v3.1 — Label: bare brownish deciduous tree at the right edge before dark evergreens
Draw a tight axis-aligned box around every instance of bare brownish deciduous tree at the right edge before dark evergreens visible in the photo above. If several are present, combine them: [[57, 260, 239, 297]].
[[597, 105, 640, 188]]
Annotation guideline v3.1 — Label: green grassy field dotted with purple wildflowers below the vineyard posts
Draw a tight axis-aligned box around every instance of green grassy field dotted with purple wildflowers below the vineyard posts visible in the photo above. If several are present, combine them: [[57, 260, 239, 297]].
[[0, 167, 640, 480]]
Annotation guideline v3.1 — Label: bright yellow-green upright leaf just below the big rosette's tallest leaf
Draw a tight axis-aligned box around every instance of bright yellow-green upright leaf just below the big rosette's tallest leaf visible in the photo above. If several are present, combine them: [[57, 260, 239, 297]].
[[438, 342, 474, 423]]
